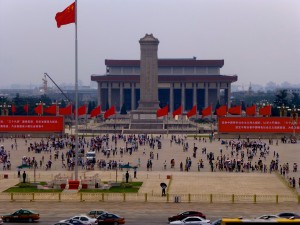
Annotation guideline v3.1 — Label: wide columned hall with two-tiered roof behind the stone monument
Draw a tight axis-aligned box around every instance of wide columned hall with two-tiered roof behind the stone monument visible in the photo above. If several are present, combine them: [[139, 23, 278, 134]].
[[91, 57, 238, 112]]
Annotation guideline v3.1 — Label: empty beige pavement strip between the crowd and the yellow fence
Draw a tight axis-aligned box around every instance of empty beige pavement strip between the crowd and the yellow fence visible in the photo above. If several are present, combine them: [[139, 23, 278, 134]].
[[0, 171, 296, 200]]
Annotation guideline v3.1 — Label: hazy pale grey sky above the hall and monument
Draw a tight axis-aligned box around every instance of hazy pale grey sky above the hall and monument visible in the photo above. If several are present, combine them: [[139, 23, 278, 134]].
[[0, 0, 300, 87]]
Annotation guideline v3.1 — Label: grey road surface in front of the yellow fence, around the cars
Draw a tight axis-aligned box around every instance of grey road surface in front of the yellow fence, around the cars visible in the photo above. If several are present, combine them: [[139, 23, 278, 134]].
[[0, 202, 300, 225]]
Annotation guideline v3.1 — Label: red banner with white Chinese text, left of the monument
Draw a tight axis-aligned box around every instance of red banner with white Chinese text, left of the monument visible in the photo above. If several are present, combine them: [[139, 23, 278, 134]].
[[0, 116, 64, 132]]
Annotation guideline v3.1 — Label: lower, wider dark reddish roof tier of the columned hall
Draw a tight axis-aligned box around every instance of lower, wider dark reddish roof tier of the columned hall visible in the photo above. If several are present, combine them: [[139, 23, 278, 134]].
[[91, 74, 238, 83]]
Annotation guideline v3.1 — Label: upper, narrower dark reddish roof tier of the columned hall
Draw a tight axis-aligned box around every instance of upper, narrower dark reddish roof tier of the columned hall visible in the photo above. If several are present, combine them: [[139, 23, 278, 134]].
[[105, 59, 224, 68]]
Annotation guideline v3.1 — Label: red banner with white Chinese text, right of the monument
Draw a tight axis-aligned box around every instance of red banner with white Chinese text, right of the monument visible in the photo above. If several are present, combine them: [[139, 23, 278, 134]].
[[219, 117, 300, 133]]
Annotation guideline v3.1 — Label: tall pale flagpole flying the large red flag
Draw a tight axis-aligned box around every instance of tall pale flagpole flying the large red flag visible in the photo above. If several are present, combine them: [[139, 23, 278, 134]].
[[75, 0, 79, 180]]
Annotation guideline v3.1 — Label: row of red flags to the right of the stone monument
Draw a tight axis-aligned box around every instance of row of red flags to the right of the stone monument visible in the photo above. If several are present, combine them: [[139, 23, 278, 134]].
[[156, 105, 271, 118]]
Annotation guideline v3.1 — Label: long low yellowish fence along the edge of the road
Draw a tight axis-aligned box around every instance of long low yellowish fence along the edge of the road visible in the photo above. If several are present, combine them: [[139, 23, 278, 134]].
[[0, 192, 300, 204]]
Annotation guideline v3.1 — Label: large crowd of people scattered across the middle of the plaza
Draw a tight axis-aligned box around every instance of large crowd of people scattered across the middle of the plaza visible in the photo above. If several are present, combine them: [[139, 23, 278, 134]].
[[0, 134, 300, 190]]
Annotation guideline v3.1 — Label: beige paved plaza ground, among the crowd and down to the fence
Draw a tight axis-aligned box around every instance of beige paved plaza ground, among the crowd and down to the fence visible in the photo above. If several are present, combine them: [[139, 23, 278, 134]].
[[0, 134, 300, 198]]
